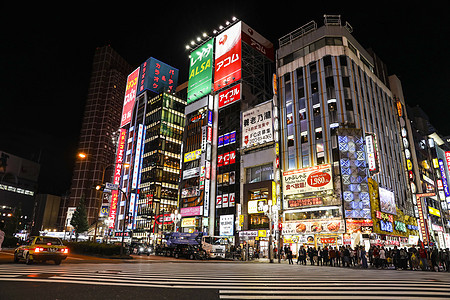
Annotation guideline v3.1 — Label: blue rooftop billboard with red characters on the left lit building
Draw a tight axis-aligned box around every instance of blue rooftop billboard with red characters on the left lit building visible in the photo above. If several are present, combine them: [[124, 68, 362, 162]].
[[137, 57, 178, 95]]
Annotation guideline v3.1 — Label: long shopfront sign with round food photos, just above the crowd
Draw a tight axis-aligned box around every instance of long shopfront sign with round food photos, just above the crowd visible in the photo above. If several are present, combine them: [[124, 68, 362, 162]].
[[282, 220, 345, 235]]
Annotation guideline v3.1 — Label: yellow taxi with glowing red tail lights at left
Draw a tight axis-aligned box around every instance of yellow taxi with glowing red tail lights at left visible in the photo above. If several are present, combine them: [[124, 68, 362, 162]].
[[14, 236, 69, 265]]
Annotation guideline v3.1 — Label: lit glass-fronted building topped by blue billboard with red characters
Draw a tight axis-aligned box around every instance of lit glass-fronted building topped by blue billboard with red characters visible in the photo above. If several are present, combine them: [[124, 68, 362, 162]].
[[108, 57, 186, 242]]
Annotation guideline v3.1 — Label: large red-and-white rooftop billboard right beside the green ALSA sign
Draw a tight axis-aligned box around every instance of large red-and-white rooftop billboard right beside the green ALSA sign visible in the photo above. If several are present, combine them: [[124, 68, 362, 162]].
[[214, 22, 241, 91]]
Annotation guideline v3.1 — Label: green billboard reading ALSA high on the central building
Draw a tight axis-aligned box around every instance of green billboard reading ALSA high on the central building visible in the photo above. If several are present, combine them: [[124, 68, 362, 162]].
[[187, 39, 214, 104]]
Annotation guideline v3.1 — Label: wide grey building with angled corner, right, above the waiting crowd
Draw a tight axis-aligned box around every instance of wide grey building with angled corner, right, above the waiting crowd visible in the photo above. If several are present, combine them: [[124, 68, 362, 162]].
[[277, 15, 419, 251]]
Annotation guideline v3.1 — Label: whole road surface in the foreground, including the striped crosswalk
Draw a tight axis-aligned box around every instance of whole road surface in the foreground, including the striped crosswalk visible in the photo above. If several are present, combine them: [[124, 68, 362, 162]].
[[0, 253, 450, 300]]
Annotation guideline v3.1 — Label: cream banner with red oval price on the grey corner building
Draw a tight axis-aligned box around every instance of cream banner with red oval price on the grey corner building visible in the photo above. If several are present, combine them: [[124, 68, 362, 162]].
[[283, 164, 333, 196]]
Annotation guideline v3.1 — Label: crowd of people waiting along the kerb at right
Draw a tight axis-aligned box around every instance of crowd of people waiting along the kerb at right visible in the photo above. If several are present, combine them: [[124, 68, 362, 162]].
[[282, 245, 450, 272]]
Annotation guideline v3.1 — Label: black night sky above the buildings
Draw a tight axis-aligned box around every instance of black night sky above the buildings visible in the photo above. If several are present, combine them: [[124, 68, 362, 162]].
[[0, 1, 450, 194]]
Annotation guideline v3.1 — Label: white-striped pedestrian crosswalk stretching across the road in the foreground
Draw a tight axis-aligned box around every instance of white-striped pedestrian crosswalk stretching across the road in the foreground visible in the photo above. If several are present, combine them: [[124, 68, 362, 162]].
[[0, 263, 450, 299]]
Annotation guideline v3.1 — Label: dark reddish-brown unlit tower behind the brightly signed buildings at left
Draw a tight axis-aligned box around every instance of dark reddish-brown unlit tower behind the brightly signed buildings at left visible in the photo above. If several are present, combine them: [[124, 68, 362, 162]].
[[58, 46, 132, 229]]
